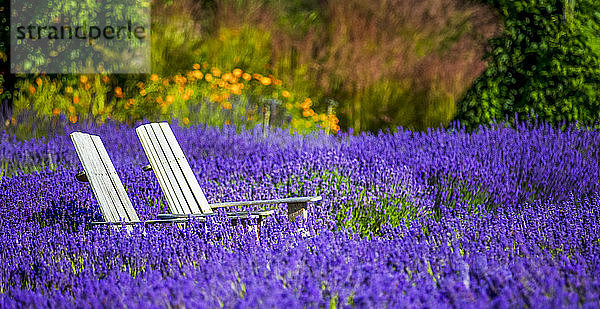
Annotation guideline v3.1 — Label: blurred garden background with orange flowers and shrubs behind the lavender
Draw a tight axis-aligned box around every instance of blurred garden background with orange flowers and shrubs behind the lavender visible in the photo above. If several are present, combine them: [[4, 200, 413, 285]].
[[0, 0, 600, 137]]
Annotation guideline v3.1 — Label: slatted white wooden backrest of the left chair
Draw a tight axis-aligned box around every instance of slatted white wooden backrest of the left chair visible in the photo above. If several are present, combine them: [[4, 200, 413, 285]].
[[71, 132, 140, 222]]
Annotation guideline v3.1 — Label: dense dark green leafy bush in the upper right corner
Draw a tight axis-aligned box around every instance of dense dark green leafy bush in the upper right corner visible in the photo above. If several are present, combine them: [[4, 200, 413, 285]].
[[456, 0, 600, 128]]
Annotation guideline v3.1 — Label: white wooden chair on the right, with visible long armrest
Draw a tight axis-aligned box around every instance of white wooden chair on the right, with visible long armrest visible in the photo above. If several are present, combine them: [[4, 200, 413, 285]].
[[136, 122, 321, 221]]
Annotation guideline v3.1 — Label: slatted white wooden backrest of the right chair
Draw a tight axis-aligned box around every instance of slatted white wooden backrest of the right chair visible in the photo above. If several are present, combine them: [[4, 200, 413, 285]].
[[135, 122, 213, 214]]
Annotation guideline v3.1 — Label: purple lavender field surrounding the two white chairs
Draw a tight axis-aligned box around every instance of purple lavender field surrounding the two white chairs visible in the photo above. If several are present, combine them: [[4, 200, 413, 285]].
[[0, 124, 600, 308]]
